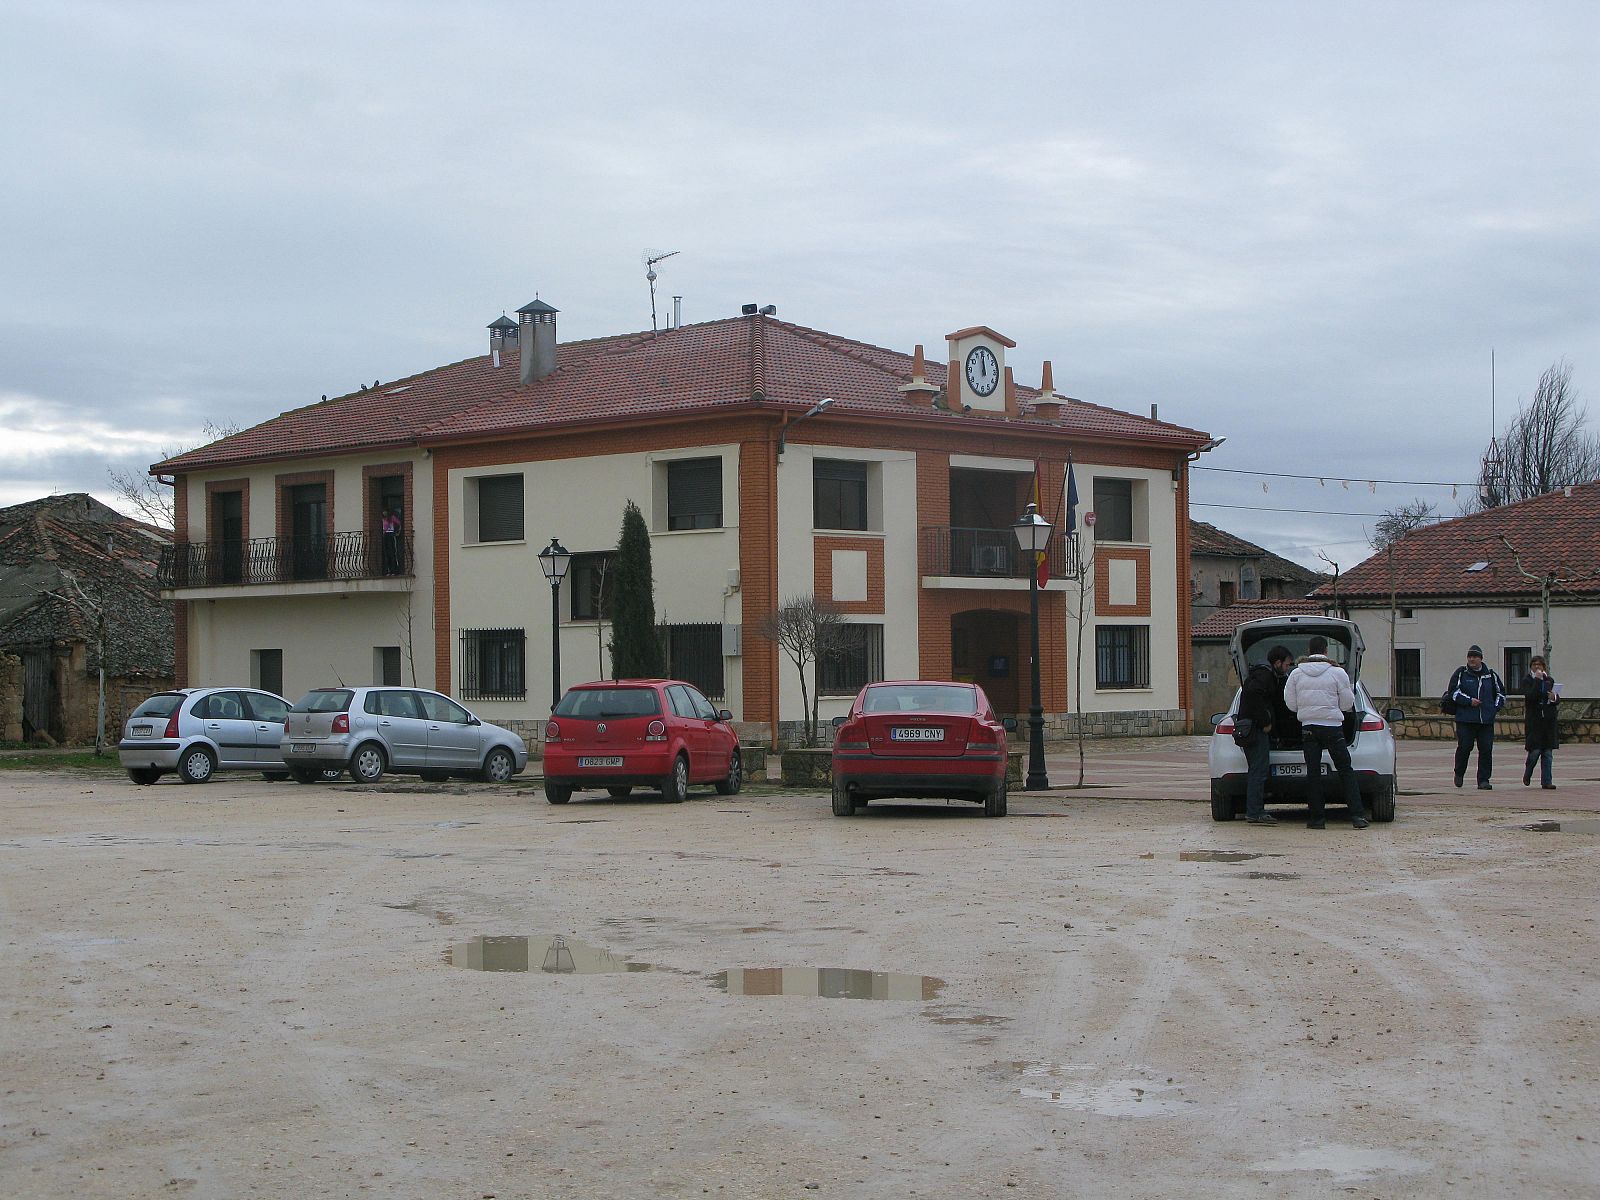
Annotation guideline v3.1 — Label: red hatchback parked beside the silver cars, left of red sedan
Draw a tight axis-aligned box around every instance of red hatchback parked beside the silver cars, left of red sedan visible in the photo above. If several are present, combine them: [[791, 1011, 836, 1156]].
[[544, 678, 744, 805]]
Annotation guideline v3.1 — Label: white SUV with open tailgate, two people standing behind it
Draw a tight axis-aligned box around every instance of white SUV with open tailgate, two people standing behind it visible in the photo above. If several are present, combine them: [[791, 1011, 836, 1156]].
[[1206, 614, 1405, 821]]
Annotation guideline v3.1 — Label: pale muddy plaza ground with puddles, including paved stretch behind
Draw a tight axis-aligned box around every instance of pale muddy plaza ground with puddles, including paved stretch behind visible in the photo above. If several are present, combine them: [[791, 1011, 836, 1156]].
[[0, 738, 1600, 1200]]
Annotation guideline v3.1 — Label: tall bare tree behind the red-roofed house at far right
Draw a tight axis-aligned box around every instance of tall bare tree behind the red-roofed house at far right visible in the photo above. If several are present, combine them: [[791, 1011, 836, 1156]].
[[1477, 358, 1600, 509]]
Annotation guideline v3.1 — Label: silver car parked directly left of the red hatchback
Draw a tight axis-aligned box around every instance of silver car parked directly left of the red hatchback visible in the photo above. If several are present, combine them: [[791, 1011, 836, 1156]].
[[280, 688, 528, 784]]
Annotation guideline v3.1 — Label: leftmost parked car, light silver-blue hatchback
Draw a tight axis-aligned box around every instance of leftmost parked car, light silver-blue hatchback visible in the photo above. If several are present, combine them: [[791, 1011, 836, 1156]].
[[117, 688, 302, 784]]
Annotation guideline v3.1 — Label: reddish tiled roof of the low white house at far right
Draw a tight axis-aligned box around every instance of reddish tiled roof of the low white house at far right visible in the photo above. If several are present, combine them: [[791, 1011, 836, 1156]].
[[1315, 482, 1600, 602]]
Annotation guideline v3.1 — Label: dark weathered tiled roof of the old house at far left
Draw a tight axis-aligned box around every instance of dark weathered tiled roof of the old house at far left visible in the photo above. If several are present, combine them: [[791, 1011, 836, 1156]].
[[0, 493, 173, 675]]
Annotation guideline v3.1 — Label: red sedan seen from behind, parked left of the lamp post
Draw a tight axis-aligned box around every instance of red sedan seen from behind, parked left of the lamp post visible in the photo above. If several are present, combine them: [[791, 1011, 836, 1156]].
[[834, 680, 1016, 816]]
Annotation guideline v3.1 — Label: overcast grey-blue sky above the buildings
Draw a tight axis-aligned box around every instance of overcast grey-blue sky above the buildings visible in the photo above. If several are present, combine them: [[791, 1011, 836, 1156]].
[[0, 0, 1600, 568]]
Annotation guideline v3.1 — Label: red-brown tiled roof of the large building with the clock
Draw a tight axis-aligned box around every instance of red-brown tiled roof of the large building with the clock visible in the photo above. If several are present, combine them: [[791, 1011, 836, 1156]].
[[154, 315, 1206, 474]]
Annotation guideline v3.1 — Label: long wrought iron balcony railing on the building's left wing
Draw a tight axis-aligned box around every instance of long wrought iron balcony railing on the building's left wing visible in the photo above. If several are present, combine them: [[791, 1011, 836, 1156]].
[[157, 533, 411, 587]]
